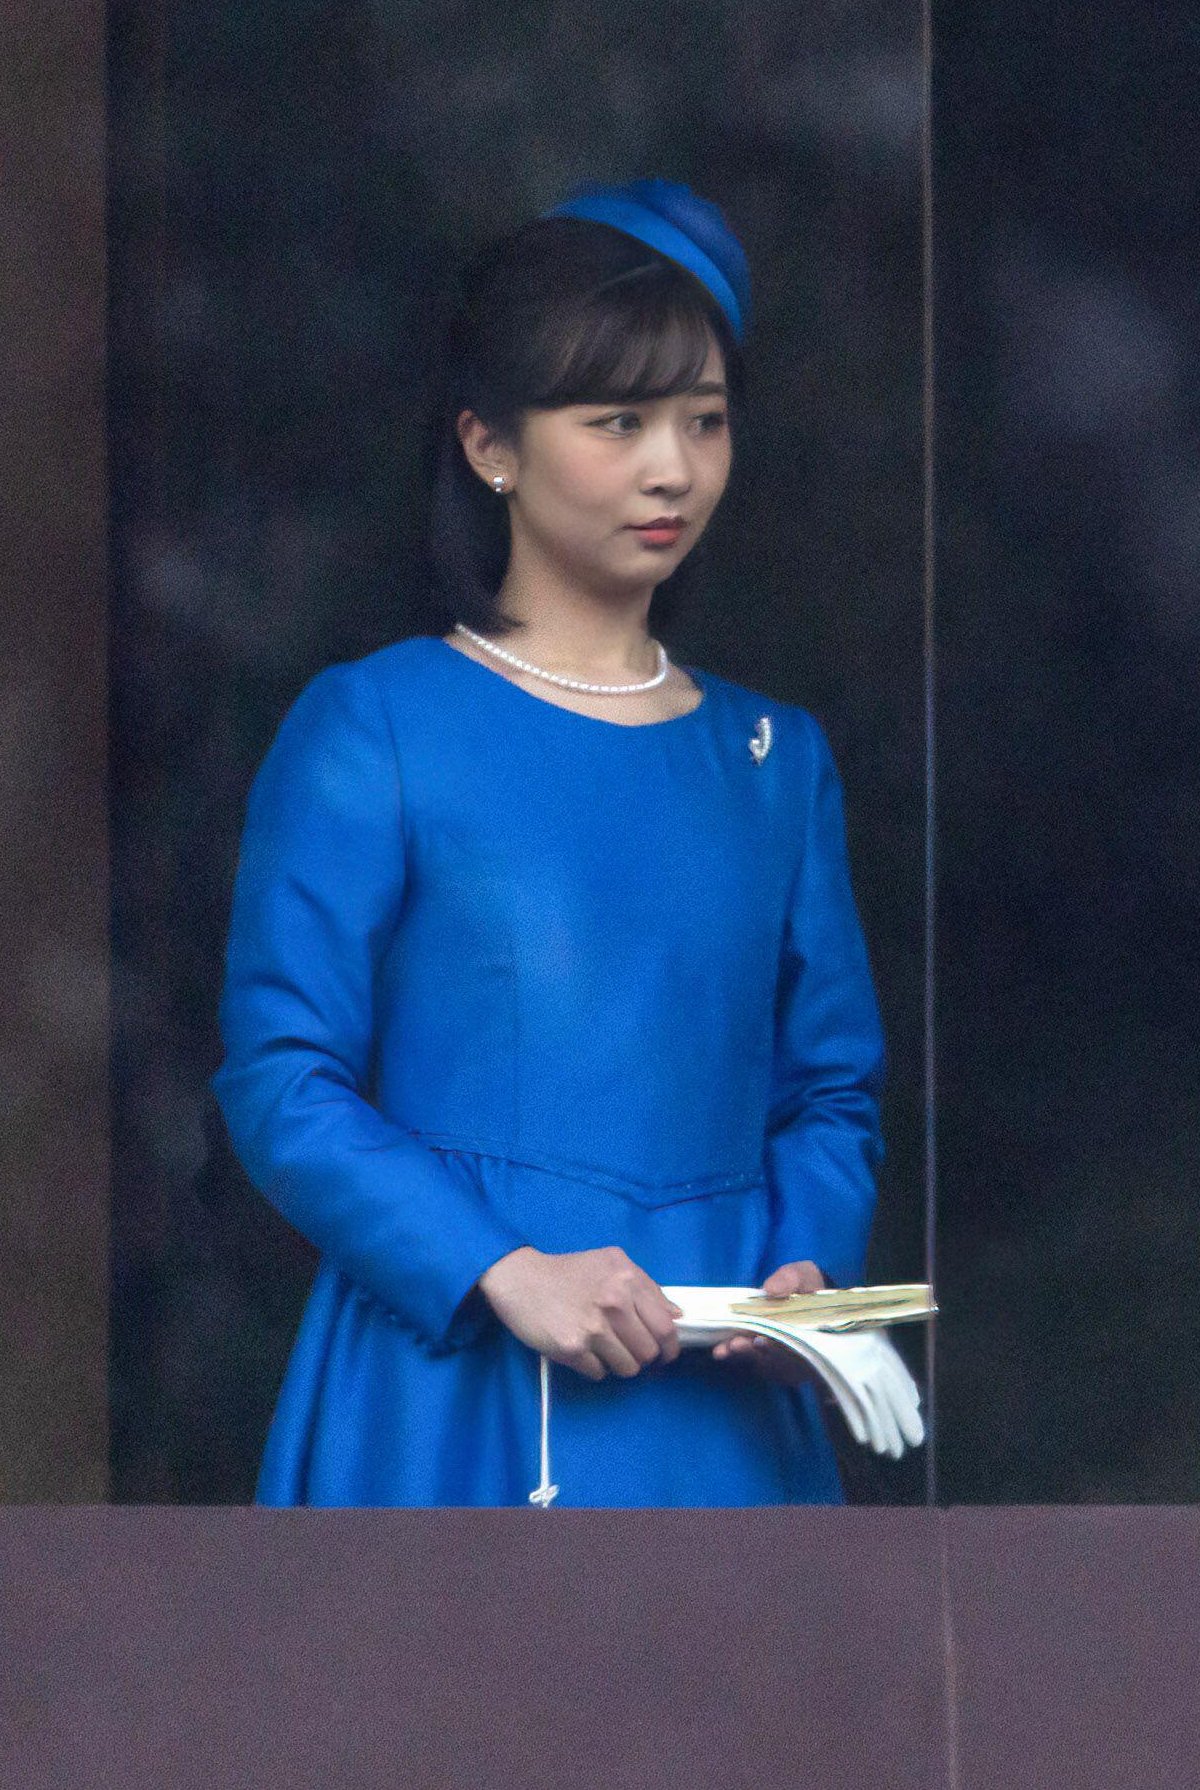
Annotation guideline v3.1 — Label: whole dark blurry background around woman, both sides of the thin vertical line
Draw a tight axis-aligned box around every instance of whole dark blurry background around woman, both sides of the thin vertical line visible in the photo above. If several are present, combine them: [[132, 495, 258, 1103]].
[[109, 0, 1200, 1502]]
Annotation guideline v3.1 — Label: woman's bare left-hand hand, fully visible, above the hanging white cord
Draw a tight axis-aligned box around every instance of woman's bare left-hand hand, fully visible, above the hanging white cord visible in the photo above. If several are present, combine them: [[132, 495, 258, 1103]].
[[478, 1244, 682, 1380]]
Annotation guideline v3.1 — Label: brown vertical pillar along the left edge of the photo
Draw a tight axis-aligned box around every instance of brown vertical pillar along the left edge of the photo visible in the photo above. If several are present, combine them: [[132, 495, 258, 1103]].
[[0, 0, 109, 1502]]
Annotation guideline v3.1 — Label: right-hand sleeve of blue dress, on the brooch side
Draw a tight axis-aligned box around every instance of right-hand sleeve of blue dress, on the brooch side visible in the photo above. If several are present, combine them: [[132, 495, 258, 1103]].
[[765, 716, 883, 1287]]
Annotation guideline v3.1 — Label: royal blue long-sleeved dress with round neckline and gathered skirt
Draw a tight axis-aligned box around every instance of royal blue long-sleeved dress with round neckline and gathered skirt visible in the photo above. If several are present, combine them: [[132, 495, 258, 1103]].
[[211, 635, 883, 1509]]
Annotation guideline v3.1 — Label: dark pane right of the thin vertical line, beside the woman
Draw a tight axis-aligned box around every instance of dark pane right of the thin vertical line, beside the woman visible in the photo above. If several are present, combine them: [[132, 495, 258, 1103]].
[[935, 5, 1200, 1504]]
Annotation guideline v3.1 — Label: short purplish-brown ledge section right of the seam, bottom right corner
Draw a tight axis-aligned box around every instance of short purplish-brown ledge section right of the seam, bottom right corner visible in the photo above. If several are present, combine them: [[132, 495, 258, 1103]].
[[947, 1505, 1200, 1790]]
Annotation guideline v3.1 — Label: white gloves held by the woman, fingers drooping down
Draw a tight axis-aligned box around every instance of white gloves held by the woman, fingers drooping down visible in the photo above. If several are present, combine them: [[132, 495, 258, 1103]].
[[663, 1287, 924, 1461]]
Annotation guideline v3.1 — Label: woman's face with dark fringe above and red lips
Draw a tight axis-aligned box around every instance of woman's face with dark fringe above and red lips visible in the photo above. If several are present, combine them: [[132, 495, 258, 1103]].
[[480, 329, 733, 592]]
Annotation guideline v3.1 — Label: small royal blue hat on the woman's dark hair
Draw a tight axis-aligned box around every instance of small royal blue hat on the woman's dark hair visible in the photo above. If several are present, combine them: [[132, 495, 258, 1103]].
[[541, 181, 750, 342]]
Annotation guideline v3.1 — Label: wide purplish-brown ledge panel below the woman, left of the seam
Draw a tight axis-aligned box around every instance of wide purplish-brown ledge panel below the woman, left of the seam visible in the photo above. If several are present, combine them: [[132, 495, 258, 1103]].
[[0, 1507, 944, 1790]]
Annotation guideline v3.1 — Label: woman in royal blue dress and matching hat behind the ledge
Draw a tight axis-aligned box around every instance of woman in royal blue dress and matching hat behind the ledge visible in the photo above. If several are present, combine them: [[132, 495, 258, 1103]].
[[213, 181, 883, 1505]]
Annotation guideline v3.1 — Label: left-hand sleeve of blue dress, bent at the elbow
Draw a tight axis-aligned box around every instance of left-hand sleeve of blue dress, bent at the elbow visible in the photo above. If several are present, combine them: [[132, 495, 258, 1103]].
[[210, 662, 525, 1351]]
